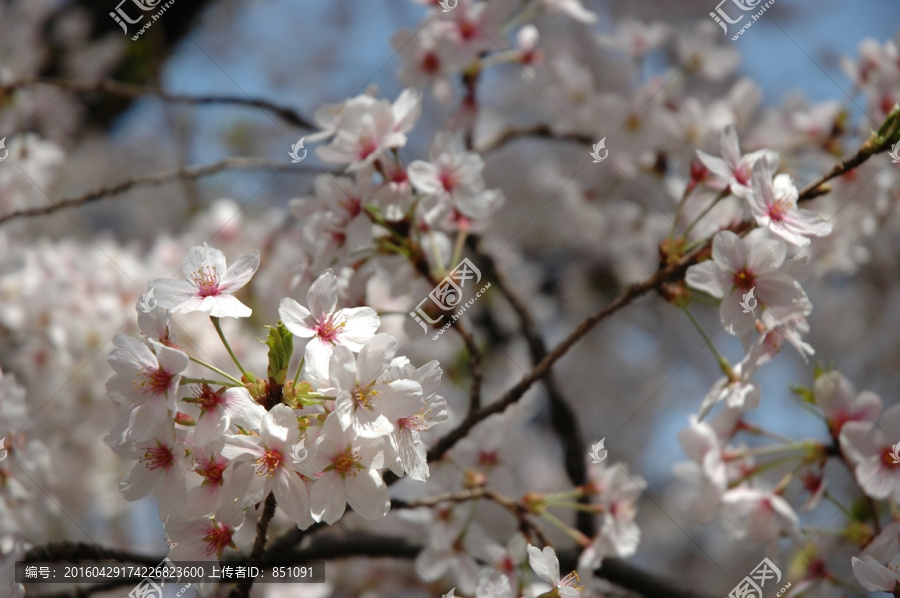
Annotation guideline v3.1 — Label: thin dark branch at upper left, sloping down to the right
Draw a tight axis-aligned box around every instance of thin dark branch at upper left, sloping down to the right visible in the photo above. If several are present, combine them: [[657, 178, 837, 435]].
[[0, 77, 318, 130]]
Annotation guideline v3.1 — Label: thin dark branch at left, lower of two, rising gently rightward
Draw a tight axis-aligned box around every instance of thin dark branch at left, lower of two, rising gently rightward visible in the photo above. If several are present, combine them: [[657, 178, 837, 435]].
[[0, 158, 320, 224]]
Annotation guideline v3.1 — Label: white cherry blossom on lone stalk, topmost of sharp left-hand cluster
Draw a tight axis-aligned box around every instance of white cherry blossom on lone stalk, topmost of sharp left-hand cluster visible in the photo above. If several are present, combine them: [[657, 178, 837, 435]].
[[149, 243, 259, 318]]
